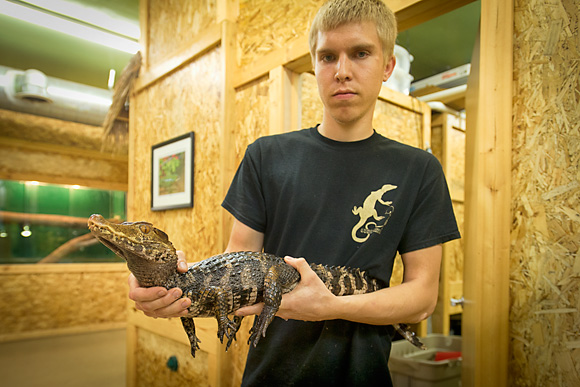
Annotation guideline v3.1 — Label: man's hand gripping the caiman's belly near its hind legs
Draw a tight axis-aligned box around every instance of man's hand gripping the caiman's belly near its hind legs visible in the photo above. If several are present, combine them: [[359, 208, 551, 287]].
[[235, 257, 336, 321]]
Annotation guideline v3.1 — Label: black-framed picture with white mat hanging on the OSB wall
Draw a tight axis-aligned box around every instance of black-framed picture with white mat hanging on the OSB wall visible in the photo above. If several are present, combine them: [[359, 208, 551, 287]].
[[151, 132, 195, 211]]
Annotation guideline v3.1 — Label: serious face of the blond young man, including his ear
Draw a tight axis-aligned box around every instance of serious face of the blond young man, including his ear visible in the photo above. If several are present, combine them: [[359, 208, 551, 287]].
[[314, 22, 395, 124]]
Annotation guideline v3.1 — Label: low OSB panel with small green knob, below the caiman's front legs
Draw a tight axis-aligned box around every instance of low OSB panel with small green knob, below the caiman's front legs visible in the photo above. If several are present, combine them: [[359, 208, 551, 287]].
[[134, 329, 209, 387]]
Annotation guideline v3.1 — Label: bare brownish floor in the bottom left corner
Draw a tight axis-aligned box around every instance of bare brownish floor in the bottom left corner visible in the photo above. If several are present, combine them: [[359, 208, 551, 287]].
[[0, 329, 126, 387]]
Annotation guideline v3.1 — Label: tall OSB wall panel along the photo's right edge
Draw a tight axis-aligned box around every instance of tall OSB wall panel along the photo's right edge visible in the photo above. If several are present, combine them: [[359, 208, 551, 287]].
[[509, 0, 580, 386]]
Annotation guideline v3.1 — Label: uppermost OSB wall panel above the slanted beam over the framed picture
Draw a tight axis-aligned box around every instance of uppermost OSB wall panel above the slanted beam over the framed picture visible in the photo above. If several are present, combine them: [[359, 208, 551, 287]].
[[147, 0, 216, 66]]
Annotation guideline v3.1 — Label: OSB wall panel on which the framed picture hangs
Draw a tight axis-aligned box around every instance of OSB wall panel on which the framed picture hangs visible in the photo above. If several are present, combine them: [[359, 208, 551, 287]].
[[129, 48, 223, 262]]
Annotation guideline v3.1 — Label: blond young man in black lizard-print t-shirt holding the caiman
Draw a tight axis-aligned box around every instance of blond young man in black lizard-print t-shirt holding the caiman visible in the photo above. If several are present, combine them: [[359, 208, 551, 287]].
[[130, 0, 459, 386]]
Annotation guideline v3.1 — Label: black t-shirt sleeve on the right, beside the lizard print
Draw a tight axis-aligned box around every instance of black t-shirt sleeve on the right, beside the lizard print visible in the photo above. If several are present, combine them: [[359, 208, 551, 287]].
[[398, 157, 461, 254]]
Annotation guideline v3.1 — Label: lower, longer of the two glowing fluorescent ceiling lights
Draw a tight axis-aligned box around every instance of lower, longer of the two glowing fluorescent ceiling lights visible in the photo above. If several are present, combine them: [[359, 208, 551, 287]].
[[0, 0, 140, 54]]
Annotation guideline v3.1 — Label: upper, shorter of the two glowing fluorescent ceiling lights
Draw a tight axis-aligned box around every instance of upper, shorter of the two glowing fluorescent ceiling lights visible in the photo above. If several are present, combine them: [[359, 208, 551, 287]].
[[20, 0, 141, 40]]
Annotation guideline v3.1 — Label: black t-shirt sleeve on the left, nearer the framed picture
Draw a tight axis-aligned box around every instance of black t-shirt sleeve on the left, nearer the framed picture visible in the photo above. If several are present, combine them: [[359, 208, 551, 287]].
[[222, 143, 266, 232]]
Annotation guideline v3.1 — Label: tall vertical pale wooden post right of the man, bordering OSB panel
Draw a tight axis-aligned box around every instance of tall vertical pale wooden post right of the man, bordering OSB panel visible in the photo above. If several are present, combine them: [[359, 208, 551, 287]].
[[462, 0, 514, 387]]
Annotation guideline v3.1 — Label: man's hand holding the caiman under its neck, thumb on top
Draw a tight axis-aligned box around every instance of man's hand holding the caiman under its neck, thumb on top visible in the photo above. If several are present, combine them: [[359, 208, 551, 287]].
[[129, 251, 191, 318]]
